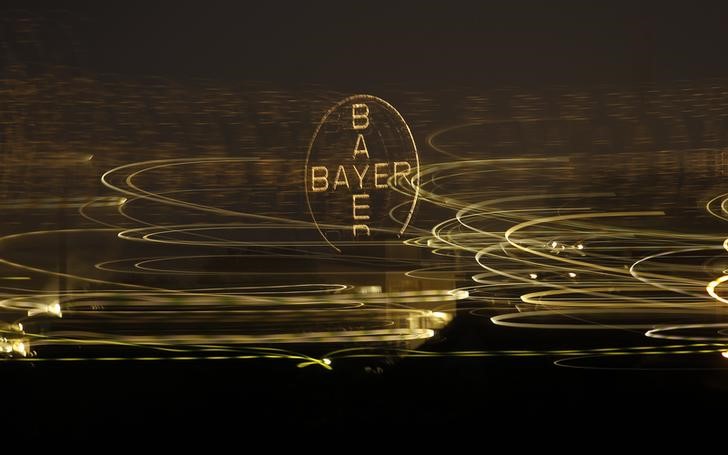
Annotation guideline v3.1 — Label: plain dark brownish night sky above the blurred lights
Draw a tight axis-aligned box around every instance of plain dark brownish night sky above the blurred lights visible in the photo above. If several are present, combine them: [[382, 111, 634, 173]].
[[12, 0, 728, 88]]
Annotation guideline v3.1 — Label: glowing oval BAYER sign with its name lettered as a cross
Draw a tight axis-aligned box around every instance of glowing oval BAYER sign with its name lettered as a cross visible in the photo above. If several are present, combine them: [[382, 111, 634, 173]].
[[305, 95, 420, 251]]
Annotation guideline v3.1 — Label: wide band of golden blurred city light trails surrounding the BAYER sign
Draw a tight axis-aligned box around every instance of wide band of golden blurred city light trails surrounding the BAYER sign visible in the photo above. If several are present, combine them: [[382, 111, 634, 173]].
[[0, 24, 728, 369]]
